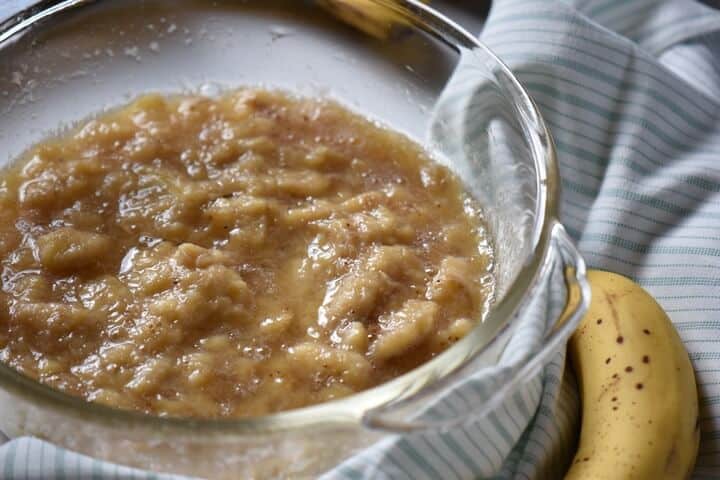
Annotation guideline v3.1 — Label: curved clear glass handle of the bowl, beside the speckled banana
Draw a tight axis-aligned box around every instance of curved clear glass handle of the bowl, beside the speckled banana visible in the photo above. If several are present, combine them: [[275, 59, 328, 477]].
[[362, 222, 590, 433]]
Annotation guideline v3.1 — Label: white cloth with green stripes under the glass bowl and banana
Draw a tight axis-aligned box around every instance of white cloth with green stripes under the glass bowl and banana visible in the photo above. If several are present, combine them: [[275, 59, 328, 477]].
[[0, 0, 720, 480]]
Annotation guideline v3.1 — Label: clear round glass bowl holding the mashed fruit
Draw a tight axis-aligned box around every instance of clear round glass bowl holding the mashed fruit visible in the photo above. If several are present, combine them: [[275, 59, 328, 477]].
[[0, 0, 589, 478]]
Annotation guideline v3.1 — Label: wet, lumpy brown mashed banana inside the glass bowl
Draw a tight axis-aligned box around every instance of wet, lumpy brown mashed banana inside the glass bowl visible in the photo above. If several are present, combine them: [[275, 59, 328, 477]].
[[0, 89, 493, 417]]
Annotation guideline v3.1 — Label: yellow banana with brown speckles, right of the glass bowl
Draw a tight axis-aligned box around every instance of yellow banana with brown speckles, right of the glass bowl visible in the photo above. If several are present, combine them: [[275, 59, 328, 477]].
[[565, 271, 700, 480]]
